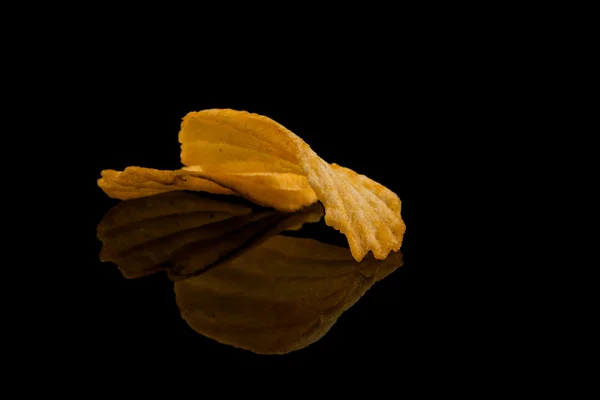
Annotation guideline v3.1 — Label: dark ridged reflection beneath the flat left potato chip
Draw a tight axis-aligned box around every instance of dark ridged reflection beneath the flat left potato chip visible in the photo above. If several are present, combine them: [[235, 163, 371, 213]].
[[97, 191, 323, 280]]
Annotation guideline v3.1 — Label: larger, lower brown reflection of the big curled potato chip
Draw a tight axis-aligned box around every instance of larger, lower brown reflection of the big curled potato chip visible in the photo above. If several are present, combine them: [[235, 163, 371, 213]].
[[175, 236, 403, 354]]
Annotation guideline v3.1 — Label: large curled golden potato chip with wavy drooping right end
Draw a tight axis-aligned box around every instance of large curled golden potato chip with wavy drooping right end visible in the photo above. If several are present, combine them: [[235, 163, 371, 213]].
[[179, 109, 406, 261]]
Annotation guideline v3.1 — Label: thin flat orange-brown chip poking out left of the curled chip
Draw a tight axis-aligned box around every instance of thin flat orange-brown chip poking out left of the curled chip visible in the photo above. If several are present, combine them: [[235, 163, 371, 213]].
[[98, 167, 235, 200]]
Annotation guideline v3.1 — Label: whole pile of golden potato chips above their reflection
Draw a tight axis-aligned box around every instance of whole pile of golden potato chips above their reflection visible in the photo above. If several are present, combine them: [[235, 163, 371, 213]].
[[98, 109, 406, 261]]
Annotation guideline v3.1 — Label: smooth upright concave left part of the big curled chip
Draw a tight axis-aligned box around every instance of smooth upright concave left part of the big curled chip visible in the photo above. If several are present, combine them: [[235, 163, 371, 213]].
[[179, 110, 317, 212]]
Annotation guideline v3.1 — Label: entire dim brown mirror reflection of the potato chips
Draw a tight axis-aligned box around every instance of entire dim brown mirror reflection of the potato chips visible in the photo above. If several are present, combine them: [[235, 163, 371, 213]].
[[98, 192, 402, 354]]
